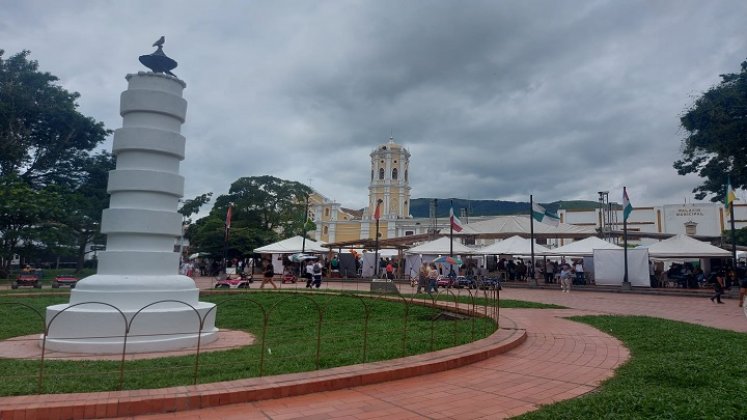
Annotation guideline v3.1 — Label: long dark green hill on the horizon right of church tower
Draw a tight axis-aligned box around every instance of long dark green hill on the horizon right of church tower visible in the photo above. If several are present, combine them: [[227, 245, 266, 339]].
[[410, 198, 608, 217]]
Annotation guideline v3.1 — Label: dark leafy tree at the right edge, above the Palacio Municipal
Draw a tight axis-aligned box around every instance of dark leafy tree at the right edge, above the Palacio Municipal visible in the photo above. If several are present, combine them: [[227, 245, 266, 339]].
[[674, 61, 747, 201]]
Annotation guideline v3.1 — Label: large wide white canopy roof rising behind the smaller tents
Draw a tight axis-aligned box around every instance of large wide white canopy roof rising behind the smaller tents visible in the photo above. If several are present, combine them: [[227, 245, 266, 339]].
[[459, 216, 596, 238]]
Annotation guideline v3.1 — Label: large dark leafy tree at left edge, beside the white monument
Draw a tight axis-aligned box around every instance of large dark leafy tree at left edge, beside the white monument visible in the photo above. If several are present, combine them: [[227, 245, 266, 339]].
[[0, 50, 109, 268]]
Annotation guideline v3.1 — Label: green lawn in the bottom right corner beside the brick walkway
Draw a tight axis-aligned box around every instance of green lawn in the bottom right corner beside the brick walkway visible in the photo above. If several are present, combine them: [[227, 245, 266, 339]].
[[518, 316, 747, 419]]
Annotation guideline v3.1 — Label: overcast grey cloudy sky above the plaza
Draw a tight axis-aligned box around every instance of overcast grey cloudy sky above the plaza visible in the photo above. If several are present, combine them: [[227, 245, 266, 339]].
[[0, 0, 747, 208]]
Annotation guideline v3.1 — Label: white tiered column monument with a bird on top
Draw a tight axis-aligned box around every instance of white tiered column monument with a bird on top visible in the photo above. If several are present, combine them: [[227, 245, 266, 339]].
[[46, 43, 218, 353]]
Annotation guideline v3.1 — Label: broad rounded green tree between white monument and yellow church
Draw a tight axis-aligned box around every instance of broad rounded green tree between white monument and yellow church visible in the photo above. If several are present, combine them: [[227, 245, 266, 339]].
[[188, 175, 312, 258]]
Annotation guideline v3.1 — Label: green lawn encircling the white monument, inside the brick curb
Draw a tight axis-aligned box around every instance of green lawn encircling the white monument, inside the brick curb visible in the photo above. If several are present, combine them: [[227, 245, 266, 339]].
[[0, 292, 495, 395]]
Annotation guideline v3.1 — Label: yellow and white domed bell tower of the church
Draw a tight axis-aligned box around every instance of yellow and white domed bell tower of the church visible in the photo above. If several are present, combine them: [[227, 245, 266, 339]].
[[367, 137, 410, 220]]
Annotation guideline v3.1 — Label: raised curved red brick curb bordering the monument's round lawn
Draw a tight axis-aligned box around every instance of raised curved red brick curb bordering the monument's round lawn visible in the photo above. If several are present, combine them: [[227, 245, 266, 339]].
[[0, 316, 527, 420]]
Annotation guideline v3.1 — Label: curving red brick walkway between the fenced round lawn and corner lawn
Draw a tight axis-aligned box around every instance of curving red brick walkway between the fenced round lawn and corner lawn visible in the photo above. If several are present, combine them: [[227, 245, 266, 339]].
[[109, 309, 628, 419]]
